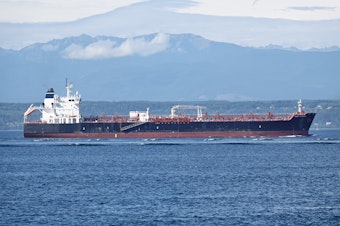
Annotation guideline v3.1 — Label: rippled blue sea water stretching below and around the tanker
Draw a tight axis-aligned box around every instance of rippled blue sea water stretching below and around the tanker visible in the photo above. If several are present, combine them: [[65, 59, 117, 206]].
[[0, 130, 340, 225]]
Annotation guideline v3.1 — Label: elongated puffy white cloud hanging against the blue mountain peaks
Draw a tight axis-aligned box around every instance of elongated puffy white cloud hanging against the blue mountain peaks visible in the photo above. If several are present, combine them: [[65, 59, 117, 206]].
[[63, 33, 169, 60]]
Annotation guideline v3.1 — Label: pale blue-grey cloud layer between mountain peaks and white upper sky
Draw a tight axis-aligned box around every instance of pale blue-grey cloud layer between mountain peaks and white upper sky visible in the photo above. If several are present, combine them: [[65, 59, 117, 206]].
[[0, 0, 340, 49]]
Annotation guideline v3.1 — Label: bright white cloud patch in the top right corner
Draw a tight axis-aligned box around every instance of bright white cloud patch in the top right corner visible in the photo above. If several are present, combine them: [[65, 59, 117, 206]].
[[177, 0, 340, 20]]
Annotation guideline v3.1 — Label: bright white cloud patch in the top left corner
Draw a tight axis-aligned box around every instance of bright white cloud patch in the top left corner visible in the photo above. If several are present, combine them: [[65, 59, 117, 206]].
[[0, 0, 144, 23]]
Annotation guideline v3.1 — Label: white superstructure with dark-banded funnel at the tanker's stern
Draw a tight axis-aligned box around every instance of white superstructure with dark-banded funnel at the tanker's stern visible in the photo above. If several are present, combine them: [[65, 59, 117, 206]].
[[24, 80, 81, 124]]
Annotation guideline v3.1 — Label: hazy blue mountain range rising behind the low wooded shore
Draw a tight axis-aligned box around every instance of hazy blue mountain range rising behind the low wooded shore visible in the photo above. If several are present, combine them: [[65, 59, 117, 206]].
[[0, 33, 340, 103]]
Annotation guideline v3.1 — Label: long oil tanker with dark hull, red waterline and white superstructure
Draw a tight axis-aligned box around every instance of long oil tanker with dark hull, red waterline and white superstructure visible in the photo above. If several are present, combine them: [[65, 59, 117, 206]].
[[24, 81, 315, 138]]
